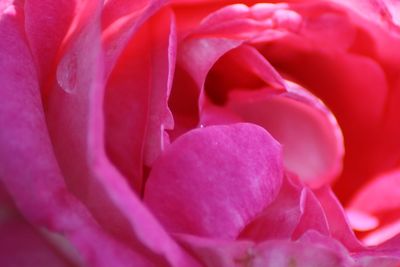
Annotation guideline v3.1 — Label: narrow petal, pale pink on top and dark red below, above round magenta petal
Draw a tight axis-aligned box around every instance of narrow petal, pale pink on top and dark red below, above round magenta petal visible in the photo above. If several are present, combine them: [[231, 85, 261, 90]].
[[170, 38, 242, 138]]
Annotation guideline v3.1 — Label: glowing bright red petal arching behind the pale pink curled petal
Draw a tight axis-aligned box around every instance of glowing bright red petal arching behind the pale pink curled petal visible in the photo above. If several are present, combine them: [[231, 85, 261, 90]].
[[263, 38, 388, 200]]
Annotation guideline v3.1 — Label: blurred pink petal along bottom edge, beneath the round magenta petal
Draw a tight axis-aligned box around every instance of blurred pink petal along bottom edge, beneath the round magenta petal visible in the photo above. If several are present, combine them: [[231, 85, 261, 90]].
[[178, 232, 358, 267]]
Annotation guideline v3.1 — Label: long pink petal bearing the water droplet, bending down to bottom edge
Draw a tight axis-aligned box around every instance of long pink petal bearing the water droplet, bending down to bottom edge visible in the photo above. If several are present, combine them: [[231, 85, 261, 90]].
[[42, 2, 196, 265]]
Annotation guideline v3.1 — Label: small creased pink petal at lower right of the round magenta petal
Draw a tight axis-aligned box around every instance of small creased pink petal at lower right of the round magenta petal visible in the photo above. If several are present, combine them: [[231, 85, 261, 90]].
[[239, 174, 330, 242]]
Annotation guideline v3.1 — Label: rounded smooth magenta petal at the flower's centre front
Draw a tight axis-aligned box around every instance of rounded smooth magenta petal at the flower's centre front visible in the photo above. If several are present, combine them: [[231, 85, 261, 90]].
[[144, 124, 282, 239]]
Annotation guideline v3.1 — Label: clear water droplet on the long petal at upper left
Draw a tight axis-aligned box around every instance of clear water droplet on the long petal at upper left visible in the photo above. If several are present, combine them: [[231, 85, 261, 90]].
[[57, 53, 78, 93]]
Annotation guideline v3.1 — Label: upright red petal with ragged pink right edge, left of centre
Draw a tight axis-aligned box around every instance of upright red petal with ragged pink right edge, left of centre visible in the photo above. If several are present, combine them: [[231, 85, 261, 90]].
[[105, 7, 176, 193]]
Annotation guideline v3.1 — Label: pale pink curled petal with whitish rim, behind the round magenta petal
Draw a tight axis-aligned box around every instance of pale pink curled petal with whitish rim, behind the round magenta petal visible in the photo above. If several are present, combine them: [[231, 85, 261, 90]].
[[227, 80, 344, 187]]
